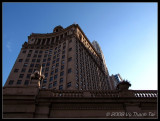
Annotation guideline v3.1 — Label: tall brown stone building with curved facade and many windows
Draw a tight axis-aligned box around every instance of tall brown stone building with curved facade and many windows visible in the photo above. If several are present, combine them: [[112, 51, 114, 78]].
[[5, 24, 111, 90]]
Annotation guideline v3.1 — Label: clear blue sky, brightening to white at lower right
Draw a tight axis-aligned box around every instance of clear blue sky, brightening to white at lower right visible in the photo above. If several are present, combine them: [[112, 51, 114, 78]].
[[2, 2, 158, 90]]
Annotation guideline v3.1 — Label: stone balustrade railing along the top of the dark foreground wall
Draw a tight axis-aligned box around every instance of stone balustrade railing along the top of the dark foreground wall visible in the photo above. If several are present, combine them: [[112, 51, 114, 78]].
[[40, 89, 158, 98]]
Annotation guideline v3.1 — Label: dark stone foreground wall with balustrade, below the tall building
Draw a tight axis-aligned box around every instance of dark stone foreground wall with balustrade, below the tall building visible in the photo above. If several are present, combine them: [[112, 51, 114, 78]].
[[3, 80, 158, 119]]
